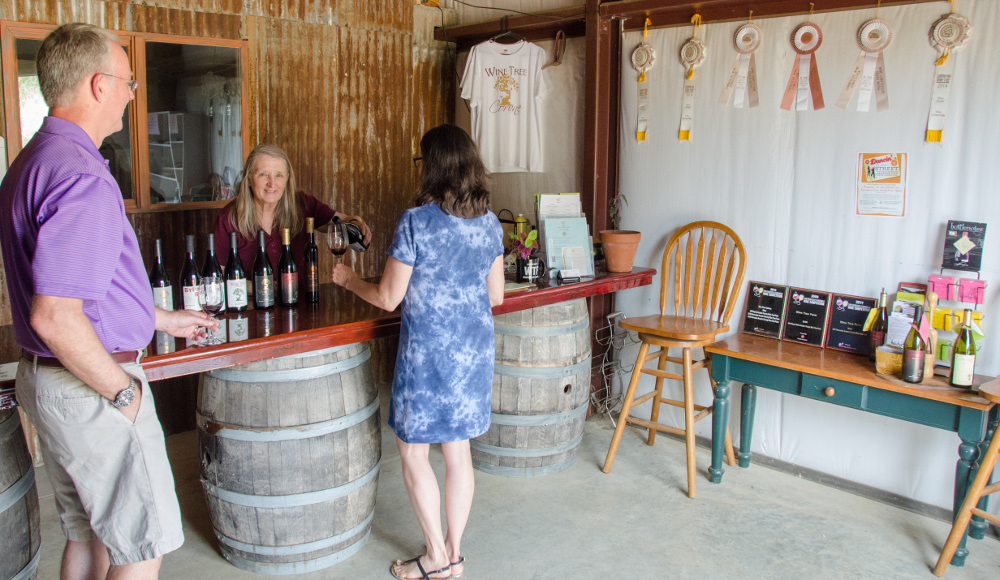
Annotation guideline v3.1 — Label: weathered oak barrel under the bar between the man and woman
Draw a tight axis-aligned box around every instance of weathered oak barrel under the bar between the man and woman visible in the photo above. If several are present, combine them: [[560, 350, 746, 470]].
[[197, 343, 382, 574]]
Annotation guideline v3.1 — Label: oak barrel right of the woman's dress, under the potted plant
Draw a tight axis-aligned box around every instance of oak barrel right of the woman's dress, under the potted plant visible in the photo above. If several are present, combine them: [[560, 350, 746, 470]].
[[471, 298, 590, 477]]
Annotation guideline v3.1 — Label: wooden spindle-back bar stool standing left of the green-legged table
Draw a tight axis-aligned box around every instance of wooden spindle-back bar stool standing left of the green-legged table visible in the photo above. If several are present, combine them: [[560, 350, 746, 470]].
[[604, 221, 746, 497]]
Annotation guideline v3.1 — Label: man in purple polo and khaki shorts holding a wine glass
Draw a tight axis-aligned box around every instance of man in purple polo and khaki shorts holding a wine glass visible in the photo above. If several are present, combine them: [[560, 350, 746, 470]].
[[0, 24, 217, 579]]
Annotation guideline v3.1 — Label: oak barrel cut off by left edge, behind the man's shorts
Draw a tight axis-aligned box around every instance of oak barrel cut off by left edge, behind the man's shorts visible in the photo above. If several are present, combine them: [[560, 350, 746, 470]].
[[0, 409, 41, 580]]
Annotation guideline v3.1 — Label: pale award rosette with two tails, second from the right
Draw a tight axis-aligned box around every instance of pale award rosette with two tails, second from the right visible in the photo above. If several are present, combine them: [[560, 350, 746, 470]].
[[837, 18, 892, 111]]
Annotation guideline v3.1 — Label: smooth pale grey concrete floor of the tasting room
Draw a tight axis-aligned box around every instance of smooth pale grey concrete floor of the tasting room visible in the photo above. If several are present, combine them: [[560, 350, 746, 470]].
[[31, 392, 1000, 580]]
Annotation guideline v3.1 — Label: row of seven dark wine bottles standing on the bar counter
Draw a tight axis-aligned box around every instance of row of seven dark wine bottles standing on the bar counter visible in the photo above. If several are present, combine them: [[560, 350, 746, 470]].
[[149, 218, 319, 312]]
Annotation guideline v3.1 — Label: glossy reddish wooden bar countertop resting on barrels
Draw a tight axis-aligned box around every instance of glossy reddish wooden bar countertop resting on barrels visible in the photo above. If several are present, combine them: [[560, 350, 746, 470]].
[[141, 268, 656, 381]]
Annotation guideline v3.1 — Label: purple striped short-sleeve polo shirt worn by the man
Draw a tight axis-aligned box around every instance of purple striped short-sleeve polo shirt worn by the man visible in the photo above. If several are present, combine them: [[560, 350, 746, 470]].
[[0, 117, 155, 356]]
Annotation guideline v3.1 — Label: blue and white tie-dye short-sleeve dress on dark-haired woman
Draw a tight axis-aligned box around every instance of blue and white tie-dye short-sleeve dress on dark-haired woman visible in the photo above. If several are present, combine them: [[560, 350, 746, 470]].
[[389, 203, 503, 443]]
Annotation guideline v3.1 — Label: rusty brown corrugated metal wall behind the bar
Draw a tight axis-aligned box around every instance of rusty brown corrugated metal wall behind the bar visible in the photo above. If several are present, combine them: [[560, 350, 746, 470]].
[[0, 0, 454, 390]]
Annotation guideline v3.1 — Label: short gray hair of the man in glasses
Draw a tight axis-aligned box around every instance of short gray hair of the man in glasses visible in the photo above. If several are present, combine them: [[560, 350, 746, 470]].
[[35, 22, 120, 107]]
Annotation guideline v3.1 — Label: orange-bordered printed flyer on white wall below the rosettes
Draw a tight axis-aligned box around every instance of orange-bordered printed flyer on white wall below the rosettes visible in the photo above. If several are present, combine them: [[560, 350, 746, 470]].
[[855, 153, 907, 217]]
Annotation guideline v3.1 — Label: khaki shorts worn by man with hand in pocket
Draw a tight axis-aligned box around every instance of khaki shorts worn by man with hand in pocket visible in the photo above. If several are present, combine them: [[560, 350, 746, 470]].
[[16, 359, 184, 565]]
